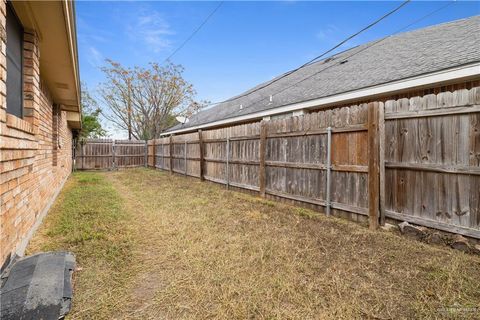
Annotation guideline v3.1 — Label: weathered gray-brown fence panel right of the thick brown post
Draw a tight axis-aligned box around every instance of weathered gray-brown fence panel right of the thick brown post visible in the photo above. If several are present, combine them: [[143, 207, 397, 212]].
[[384, 88, 480, 238]]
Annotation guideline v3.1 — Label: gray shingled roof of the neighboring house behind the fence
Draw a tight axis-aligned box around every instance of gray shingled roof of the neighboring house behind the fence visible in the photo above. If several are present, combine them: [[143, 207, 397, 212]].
[[167, 16, 480, 133]]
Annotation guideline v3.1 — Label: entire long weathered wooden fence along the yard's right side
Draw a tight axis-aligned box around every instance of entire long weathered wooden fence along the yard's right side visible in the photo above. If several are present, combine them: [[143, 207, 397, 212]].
[[148, 88, 480, 238]]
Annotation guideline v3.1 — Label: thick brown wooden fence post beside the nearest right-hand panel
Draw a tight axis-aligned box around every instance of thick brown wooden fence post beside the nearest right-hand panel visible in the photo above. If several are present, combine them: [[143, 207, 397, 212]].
[[367, 102, 380, 229]]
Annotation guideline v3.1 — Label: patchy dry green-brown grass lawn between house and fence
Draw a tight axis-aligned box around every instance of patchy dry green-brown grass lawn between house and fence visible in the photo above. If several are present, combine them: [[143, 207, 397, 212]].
[[28, 169, 480, 319]]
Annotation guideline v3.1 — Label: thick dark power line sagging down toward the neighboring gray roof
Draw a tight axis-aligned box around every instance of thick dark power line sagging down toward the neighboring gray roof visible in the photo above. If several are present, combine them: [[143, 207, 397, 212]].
[[197, 0, 411, 106]]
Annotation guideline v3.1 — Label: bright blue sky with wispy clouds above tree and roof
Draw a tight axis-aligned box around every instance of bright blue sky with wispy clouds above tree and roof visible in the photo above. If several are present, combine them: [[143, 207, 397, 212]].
[[76, 1, 480, 134]]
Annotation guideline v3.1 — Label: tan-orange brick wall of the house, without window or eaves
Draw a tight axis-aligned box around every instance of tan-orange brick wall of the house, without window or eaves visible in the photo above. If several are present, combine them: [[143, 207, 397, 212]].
[[0, 1, 72, 266]]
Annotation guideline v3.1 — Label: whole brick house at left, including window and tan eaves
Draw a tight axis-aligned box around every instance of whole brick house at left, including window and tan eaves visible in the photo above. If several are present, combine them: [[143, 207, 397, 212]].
[[0, 0, 81, 269]]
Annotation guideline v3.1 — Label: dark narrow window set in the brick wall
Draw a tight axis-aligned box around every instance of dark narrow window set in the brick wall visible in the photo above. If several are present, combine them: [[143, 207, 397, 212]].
[[7, 3, 23, 117]]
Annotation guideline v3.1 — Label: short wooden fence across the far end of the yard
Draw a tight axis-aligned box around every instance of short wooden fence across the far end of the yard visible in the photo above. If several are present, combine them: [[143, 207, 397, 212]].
[[74, 139, 147, 170]]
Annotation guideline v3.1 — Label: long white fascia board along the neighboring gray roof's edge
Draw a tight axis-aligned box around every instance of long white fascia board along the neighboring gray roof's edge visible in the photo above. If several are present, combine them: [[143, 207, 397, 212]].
[[161, 62, 480, 136]]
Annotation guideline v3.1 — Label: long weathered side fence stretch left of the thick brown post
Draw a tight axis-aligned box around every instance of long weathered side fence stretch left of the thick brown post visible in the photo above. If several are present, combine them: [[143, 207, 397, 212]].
[[148, 104, 368, 225]]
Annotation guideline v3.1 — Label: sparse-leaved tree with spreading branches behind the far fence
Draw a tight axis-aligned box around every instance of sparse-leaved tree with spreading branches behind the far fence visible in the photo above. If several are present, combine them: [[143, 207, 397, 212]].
[[99, 60, 201, 139]]
